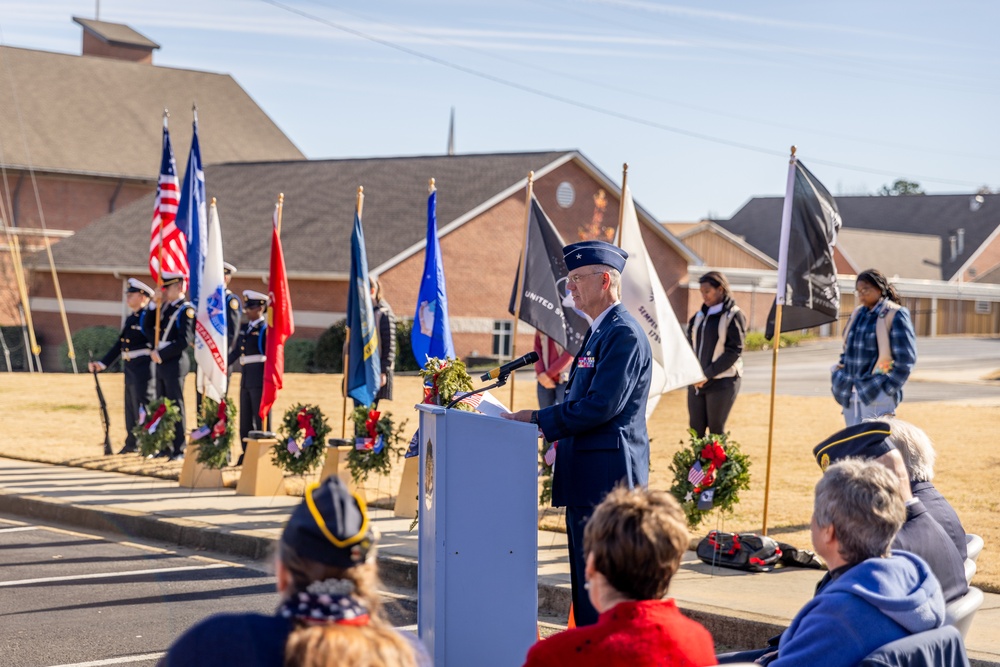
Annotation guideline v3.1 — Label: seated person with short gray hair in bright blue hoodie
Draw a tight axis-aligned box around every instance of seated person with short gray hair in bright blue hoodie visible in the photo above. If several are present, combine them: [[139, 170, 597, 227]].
[[721, 458, 945, 667]]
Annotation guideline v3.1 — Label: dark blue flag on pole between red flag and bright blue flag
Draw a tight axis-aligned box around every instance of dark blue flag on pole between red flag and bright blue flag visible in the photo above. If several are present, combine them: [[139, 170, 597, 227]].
[[346, 209, 382, 405]]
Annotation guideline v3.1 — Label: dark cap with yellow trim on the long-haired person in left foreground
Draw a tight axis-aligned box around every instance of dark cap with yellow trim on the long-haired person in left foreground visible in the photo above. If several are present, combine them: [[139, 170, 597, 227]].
[[281, 475, 376, 569]]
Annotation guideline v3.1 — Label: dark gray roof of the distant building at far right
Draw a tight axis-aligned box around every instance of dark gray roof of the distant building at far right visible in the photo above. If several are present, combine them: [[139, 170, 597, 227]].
[[715, 195, 1000, 280]]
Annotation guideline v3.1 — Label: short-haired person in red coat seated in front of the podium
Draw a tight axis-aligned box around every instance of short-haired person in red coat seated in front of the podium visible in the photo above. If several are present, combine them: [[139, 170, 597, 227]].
[[524, 486, 717, 667]]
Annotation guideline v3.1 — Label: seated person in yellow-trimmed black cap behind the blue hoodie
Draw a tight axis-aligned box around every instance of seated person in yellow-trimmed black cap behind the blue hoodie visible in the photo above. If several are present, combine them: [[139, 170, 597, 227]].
[[813, 421, 969, 602]]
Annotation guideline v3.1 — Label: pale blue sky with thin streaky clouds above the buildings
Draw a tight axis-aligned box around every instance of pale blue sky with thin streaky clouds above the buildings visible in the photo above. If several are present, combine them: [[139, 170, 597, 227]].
[[0, 0, 1000, 221]]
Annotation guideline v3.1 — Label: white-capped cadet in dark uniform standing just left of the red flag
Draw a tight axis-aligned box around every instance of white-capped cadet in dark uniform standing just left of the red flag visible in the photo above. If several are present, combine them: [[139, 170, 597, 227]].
[[229, 290, 268, 465]]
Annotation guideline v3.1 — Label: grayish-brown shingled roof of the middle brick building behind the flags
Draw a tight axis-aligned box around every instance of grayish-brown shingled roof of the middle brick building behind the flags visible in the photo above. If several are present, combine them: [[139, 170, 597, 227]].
[[52, 151, 570, 275]]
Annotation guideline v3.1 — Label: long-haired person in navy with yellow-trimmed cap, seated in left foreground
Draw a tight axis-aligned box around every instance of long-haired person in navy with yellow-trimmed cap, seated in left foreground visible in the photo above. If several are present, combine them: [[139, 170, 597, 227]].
[[160, 475, 431, 667]]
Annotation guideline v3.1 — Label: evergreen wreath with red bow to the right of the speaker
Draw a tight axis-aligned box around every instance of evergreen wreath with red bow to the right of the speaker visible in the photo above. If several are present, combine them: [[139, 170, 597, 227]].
[[670, 429, 750, 528]]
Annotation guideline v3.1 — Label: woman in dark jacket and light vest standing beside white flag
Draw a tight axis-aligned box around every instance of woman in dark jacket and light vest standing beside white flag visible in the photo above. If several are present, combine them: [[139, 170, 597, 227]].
[[687, 271, 747, 436]]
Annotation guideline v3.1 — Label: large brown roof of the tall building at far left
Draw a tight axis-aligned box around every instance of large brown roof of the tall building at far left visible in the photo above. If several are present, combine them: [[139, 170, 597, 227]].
[[0, 46, 305, 181]]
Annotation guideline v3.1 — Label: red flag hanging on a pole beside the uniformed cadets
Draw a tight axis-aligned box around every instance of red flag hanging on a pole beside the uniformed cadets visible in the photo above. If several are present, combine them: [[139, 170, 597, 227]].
[[260, 203, 295, 419]]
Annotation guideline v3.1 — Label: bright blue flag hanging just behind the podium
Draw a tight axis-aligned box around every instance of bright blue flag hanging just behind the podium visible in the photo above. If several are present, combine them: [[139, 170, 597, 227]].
[[410, 190, 455, 366]]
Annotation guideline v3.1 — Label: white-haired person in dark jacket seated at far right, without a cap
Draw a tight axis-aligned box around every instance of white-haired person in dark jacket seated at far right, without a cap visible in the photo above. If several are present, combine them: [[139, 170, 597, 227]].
[[882, 417, 969, 560]]
